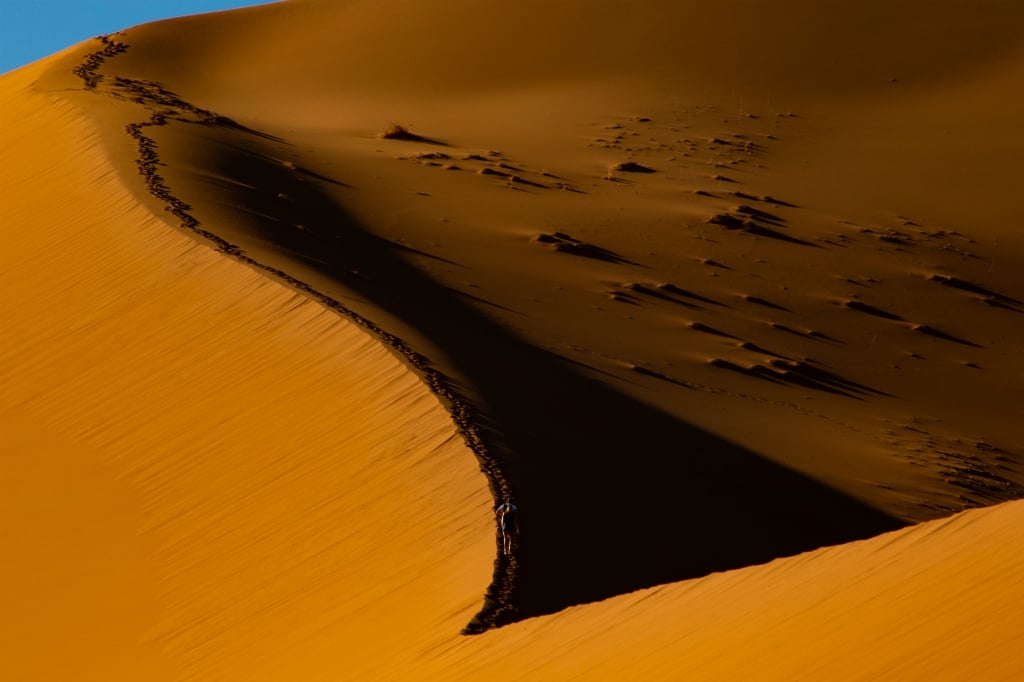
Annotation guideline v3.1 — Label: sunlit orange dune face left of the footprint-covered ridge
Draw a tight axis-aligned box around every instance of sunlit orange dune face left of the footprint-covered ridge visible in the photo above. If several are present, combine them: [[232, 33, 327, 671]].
[[0, 61, 494, 681]]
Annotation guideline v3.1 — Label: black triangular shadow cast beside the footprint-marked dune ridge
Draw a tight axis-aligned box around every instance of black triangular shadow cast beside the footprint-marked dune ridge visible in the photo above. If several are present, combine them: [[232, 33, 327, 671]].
[[155, 123, 901, 633]]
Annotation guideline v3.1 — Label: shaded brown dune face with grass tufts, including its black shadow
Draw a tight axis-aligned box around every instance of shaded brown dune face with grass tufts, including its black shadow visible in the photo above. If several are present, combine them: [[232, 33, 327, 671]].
[[41, 0, 1024, 625]]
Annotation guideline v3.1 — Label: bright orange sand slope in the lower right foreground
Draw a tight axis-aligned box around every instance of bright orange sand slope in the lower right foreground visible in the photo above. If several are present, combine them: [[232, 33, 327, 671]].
[[428, 502, 1024, 681]]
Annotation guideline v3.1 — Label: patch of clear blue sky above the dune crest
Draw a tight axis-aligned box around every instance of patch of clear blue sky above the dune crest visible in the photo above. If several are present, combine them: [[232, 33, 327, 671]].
[[0, 0, 276, 74]]
